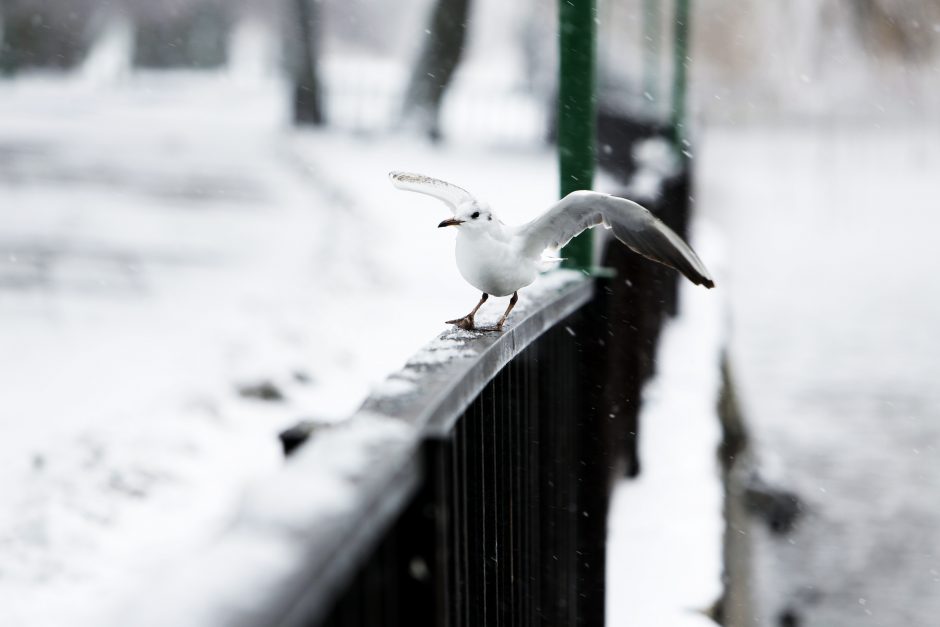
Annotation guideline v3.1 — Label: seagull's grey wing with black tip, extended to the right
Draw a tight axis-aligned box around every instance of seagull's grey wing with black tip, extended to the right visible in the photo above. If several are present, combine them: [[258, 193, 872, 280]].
[[516, 191, 715, 287]]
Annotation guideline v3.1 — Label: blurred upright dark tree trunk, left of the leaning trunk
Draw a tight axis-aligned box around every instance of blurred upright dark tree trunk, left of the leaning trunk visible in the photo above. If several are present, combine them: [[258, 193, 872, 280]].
[[288, 0, 325, 125]]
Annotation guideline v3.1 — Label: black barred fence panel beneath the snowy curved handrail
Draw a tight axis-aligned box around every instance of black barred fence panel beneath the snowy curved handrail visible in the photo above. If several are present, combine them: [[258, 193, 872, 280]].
[[323, 283, 610, 627]]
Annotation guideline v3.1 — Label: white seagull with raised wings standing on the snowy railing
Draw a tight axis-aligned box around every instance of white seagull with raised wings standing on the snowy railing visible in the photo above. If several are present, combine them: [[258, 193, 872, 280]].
[[389, 172, 715, 331]]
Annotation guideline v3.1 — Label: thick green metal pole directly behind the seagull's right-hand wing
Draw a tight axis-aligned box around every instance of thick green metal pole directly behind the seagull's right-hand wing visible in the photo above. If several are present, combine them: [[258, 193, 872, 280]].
[[558, 0, 597, 270]]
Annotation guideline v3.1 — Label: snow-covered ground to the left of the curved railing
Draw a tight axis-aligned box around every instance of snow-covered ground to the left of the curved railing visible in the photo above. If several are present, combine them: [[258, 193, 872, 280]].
[[0, 67, 556, 627]]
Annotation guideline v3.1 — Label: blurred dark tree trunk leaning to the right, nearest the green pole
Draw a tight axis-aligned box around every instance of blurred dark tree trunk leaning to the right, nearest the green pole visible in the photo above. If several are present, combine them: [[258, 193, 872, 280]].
[[402, 0, 470, 141]]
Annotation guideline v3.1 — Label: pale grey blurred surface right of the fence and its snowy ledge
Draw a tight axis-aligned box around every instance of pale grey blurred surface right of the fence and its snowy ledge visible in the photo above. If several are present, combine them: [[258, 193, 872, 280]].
[[698, 123, 940, 627]]
